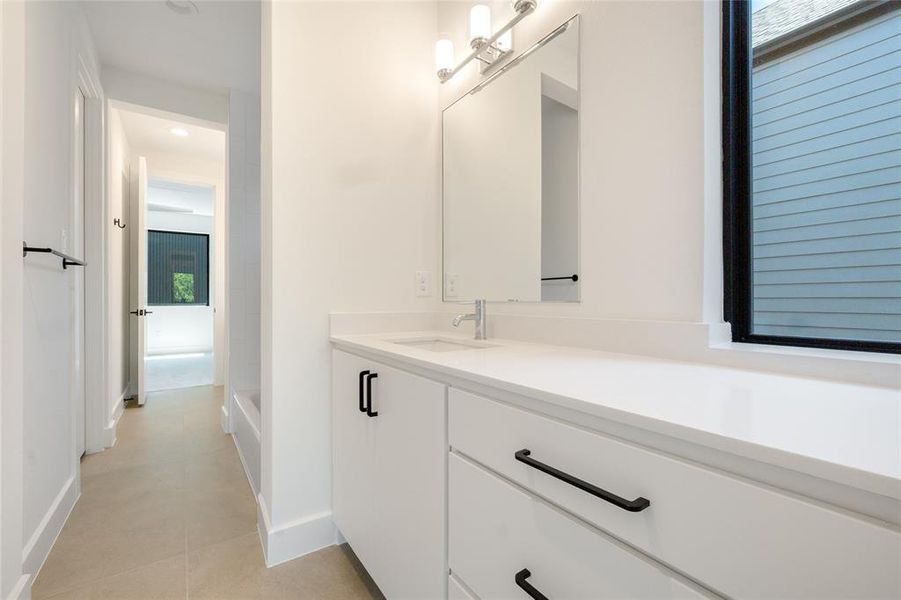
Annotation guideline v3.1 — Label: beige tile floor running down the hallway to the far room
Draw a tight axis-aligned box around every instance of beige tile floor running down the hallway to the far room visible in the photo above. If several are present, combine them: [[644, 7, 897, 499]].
[[32, 386, 381, 600]]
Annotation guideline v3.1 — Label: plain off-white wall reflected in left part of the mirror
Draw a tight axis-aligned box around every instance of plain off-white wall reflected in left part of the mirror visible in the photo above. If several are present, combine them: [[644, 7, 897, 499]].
[[437, 52, 547, 302]]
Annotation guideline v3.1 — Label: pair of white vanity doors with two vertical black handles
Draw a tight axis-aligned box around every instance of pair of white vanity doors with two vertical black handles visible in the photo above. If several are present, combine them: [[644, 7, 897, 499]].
[[332, 350, 447, 599]]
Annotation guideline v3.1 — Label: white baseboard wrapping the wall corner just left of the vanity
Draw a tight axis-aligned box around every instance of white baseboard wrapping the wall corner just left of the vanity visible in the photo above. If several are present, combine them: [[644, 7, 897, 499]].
[[257, 494, 336, 567]]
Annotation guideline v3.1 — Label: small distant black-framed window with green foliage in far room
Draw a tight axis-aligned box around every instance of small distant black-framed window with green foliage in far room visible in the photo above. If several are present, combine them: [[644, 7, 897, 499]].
[[147, 230, 210, 306]]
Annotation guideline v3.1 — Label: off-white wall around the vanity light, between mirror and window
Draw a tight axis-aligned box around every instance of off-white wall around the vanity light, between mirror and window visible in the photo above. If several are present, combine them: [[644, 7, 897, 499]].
[[438, 1, 705, 322]]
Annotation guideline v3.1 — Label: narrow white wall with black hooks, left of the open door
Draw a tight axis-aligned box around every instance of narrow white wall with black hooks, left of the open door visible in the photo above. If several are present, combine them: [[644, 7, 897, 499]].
[[106, 109, 136, 421]]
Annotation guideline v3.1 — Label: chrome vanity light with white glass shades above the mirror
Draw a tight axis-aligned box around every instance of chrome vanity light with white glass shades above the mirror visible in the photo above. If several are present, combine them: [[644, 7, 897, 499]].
[[435, 0, 538, 83]]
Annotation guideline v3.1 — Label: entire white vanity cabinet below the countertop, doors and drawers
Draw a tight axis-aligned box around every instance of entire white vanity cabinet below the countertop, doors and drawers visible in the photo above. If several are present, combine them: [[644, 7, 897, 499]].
[[333, 342, 901, 600]]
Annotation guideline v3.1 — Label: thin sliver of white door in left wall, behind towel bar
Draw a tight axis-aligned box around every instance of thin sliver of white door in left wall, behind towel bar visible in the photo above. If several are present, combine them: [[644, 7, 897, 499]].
[[74, 88, 86, 456]]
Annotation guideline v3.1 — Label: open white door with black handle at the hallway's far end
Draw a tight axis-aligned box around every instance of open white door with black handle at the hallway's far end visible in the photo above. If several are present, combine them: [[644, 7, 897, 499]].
[[129, 156, 148, 405]]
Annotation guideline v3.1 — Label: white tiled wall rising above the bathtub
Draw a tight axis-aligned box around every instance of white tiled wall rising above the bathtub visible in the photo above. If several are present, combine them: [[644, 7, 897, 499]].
[[227, 91, 260, 401]]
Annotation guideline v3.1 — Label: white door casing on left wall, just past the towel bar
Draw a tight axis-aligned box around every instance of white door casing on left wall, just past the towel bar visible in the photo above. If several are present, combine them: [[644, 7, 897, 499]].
[[70, 50, 107, 460]]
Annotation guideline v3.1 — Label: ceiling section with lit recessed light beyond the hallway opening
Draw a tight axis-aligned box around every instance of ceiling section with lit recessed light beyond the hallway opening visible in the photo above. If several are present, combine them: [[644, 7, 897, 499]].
[[118, 109, 225, 163]]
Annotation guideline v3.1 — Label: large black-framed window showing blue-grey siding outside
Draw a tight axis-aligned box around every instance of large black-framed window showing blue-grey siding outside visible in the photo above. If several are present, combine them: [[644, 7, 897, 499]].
[[722, 0, 901, 352]]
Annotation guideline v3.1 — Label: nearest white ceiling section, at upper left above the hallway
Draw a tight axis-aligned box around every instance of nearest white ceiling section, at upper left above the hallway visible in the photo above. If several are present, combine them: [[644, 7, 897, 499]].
[[82, 0, 260, 94]]
